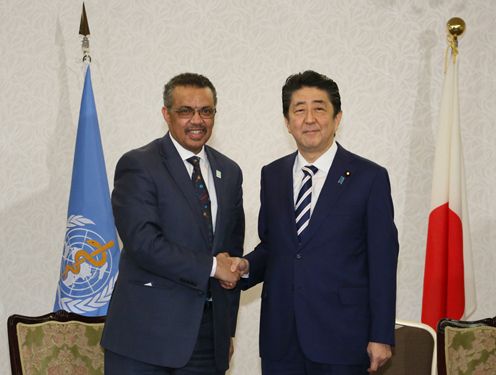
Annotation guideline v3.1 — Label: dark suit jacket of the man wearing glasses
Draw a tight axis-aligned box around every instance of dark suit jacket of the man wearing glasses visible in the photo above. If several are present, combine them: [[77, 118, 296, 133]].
[[102, 134, 244, 370]]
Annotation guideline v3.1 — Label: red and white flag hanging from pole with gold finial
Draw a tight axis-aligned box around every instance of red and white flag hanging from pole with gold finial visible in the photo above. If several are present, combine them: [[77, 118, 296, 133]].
[[422, 49, 475, 329]]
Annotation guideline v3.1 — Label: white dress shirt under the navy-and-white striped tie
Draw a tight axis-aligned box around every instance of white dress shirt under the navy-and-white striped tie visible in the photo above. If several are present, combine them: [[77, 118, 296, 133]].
[[293, 141, 338, 215]]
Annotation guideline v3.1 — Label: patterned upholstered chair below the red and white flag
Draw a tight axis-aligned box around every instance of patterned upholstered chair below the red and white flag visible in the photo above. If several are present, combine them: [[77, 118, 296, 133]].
[[437, 317, 496, 375]]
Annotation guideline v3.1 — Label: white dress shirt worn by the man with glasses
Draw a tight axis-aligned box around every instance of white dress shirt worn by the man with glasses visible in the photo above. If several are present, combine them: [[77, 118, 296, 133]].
[[171, 134, 217, 277]]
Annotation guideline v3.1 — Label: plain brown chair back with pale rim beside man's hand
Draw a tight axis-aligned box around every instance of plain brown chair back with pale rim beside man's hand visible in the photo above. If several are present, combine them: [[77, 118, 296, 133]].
[[375, 320, 436, 375]]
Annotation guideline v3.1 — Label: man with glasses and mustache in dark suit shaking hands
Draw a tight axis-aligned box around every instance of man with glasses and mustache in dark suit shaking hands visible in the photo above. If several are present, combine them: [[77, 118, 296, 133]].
[[102, 73, 244, 375]]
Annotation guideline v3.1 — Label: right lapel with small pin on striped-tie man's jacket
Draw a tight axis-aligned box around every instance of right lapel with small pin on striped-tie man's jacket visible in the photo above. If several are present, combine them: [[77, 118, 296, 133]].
[[301, 144, 353, 246]]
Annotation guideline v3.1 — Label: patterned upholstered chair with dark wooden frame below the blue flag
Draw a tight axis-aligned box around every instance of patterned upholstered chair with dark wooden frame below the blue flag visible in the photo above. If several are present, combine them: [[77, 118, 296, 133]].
[[7, 310, 105, 375]]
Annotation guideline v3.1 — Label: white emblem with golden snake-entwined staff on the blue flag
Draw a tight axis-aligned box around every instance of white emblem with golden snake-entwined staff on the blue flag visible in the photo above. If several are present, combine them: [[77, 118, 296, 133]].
[[58, 215, 118, 313]]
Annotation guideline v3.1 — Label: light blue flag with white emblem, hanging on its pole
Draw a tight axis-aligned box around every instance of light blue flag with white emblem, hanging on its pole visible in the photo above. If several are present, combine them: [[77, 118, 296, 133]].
[[54, 65, 120, 316]]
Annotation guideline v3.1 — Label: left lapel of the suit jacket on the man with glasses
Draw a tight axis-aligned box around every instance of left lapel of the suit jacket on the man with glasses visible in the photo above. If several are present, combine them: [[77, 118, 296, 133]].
[[161, 133, 208, 248]]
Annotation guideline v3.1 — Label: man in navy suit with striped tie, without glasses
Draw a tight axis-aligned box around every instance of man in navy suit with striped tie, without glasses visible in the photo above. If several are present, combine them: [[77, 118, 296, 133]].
[[230, 71, 398, 375]]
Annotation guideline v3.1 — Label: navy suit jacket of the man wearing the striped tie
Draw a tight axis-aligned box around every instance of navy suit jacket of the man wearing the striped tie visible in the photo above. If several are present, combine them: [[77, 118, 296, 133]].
[[243, 144, 398, 365]]
